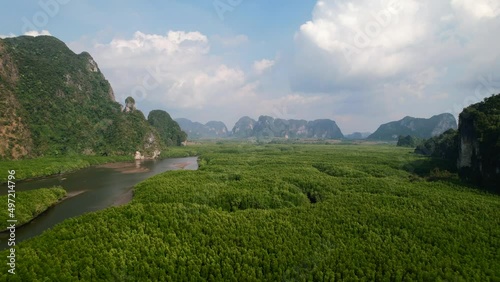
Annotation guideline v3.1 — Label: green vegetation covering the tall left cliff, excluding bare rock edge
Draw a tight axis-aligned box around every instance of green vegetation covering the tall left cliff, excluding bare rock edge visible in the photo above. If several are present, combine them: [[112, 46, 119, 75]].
[[3, 36, 120, 156]]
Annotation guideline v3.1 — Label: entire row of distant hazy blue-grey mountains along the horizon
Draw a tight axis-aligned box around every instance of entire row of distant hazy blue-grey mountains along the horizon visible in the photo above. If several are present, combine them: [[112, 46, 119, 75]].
[[176, 114, 457, 141]]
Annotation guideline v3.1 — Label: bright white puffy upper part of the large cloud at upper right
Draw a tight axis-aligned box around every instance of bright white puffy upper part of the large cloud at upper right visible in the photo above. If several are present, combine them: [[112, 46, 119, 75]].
[[296, 0, 432, 77]]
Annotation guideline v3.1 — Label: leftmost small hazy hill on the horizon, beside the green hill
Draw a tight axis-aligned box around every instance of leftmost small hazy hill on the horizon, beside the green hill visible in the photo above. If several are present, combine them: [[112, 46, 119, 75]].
[[175, 118, 229, 139]]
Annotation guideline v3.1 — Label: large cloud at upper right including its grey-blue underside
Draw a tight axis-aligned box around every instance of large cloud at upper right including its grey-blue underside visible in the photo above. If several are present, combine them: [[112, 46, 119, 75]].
[[290, 0, 500, 130]]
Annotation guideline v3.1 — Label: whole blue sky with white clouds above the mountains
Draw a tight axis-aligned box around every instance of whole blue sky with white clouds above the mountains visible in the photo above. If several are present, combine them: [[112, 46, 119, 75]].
[[0, 0, 500, 133]]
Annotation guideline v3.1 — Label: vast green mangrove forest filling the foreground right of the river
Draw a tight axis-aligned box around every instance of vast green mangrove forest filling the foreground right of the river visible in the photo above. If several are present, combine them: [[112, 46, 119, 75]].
[[0, 143, 500, 281]]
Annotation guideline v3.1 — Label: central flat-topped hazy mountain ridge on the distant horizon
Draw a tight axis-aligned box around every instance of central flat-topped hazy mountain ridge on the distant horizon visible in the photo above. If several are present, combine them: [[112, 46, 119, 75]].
[[232, 116, 344, 139]]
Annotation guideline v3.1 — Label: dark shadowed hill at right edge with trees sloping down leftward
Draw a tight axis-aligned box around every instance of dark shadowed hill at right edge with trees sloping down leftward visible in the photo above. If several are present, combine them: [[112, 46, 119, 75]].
[[415, 94, 500, 193]]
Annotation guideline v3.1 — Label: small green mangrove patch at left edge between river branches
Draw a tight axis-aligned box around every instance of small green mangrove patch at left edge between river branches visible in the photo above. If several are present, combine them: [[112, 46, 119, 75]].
[[0, 187, 66, 229]]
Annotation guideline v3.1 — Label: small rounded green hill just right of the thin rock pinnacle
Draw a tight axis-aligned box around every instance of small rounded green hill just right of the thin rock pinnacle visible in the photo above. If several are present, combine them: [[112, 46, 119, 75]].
[[148, 110, 187, 146]]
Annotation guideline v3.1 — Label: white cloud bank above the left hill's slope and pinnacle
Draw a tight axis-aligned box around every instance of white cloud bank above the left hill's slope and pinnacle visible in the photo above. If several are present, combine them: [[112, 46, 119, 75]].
[[69, 31, 258, 125]]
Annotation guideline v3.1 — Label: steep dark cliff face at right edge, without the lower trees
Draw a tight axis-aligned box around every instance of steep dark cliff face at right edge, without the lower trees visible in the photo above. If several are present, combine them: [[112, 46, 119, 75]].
[[457, 95, 500, 192]]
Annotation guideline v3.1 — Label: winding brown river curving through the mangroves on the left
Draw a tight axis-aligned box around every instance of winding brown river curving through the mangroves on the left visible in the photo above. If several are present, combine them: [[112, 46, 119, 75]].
[[0, 157, 198, 250]]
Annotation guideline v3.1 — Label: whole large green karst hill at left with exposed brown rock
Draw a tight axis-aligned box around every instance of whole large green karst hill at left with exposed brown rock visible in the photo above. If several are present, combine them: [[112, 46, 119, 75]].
[[0, 36, 186, 159]]
